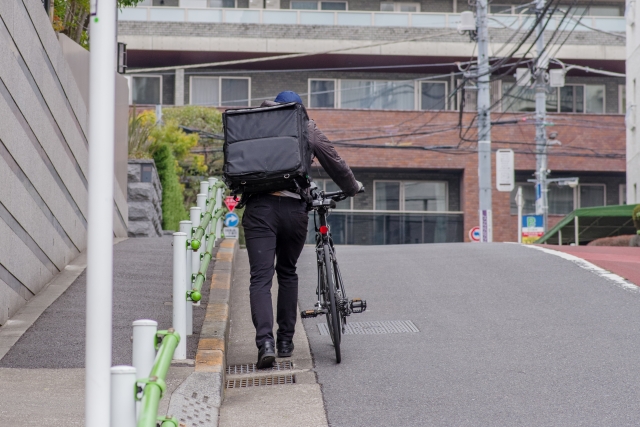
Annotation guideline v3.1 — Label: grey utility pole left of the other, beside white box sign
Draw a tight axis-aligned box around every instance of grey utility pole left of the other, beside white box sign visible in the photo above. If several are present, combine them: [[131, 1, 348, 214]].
[[476, 0, 493, 243]]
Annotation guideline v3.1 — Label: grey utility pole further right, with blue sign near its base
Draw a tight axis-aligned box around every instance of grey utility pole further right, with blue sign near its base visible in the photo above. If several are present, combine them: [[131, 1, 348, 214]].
[[535, 0, 549, 233]]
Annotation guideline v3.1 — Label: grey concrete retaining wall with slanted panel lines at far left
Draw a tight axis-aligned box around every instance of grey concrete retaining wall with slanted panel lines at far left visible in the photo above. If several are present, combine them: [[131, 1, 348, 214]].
[[0, 0, 127, 325]]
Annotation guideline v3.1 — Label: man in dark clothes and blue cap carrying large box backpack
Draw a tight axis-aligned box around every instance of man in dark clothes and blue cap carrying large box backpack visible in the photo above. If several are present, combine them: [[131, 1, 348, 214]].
[[224, 91, 362, 369]]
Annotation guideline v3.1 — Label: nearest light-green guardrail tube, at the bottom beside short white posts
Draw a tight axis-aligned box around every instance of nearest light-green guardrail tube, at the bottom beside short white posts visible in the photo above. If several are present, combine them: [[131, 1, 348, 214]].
[[136, 329, 180, 427]]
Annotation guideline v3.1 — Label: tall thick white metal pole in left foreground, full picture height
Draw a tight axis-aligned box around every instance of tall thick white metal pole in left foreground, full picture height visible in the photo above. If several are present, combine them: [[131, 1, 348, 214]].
[[85, 0, 116, 427]]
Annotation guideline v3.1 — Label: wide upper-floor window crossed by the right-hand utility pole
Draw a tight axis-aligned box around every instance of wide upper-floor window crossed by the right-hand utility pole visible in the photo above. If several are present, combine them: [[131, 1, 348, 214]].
[[502, 83, 605, 114]]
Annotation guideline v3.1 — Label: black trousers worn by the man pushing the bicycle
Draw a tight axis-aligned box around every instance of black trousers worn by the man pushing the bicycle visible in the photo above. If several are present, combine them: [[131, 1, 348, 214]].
[[242, 194, 309, 347]]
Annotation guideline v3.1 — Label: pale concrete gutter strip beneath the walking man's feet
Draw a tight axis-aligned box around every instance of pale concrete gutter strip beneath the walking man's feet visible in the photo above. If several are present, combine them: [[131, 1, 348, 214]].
[[219, 250, 328, 427]]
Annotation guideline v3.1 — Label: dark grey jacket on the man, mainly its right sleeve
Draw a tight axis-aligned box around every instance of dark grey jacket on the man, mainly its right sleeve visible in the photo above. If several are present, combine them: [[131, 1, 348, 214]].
[[261, 101, 360, 196]]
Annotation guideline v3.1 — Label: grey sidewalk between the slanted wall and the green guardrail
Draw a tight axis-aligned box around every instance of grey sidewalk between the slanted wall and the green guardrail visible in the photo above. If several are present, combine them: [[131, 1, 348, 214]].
[[0, 237, 213, 427]]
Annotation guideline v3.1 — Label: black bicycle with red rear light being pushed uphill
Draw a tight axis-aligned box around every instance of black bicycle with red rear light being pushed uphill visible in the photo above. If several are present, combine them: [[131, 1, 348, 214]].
[[300, 183, 367, 363]]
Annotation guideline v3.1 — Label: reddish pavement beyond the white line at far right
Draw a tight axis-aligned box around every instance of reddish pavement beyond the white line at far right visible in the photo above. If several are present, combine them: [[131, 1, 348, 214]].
[[541, 245, 640, 286]]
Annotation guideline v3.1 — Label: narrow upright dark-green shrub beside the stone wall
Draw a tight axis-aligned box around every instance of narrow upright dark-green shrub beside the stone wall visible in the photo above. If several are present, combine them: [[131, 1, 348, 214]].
[[153, 144, 188, 231]]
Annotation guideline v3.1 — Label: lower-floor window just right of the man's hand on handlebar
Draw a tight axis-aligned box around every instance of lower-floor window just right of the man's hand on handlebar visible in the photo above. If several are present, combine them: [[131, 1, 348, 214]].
[[374, 181, 448, 212]]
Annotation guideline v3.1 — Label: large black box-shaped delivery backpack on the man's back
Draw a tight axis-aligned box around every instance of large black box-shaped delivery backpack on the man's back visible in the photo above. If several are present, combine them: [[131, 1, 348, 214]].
[[222, 102, 312, 194]]
